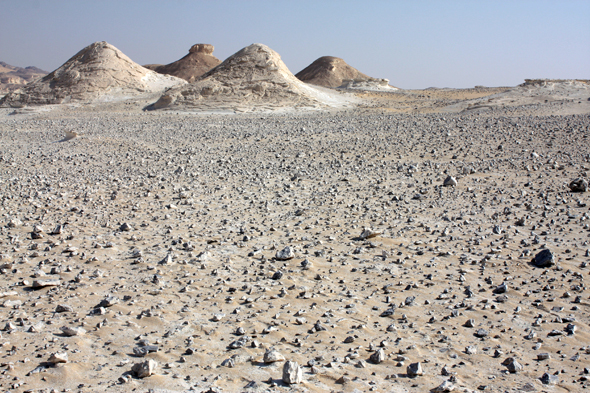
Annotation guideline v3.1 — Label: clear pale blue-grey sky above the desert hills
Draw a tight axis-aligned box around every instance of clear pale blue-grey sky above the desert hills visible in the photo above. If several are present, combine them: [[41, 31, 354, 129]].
[[0, 0, 590, 89]]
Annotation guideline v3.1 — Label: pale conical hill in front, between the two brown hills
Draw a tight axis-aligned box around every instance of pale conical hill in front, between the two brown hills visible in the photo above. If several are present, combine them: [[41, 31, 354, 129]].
[[153, 44, 356, 111]]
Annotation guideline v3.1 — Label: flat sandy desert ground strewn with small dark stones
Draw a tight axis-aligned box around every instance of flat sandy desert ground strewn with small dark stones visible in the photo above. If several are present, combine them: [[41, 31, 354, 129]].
[[0, 88, 590, 392]]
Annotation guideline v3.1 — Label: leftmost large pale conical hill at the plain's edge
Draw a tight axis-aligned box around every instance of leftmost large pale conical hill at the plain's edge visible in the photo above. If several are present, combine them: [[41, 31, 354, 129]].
[[0, 41, 186, 107]]
